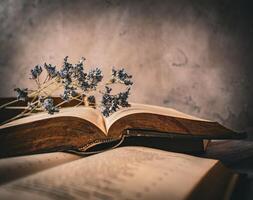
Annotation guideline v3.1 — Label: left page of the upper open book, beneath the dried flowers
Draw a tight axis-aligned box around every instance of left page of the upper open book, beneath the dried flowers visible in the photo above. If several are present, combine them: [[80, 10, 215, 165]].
[[0, 106, 106, 133]]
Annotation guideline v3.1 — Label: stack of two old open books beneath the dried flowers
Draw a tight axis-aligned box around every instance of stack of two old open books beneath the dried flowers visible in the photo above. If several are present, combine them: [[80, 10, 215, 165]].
[[0, 99, 246, 199]]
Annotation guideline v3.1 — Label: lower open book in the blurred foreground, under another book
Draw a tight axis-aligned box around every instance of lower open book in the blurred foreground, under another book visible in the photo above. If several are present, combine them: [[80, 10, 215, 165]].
[[0, 147, 243, 200]]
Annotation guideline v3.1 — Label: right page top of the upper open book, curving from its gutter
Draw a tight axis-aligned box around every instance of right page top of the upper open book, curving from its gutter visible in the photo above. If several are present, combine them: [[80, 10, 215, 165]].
[[105, 103, 209, 130]]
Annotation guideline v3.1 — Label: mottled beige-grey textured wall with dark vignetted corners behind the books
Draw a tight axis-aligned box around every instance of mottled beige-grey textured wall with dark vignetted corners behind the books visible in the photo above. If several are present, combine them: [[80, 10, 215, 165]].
[[0, 0, 253, 133]]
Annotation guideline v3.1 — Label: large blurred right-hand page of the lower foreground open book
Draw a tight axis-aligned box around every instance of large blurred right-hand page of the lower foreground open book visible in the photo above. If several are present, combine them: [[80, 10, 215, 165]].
[[0, 147, 218, 200]]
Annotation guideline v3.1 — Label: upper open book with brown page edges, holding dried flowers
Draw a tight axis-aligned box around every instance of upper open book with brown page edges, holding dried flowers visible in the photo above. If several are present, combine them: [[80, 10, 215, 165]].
[[0, 103, 244, 157]]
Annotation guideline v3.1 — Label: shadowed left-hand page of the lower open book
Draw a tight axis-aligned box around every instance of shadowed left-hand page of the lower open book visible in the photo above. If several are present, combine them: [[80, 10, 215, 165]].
[[0, 152, 81, 185]]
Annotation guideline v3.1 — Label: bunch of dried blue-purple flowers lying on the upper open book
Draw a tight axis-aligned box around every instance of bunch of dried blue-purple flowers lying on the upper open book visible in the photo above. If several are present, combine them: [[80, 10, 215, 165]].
[[0, 56, 133, 121]]
